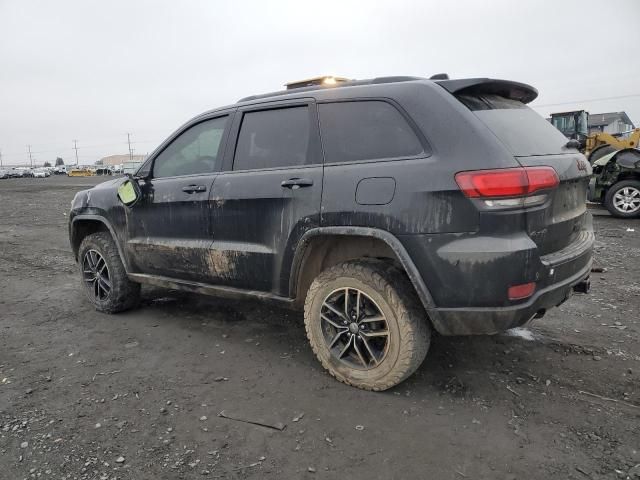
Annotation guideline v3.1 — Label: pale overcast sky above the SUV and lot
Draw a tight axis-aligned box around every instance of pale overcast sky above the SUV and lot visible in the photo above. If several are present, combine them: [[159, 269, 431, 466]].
[[0, 0, 640, 165]]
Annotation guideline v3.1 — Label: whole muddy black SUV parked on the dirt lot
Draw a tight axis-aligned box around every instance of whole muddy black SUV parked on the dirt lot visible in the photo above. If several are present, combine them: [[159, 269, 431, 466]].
[[69, 77, 594, 390]]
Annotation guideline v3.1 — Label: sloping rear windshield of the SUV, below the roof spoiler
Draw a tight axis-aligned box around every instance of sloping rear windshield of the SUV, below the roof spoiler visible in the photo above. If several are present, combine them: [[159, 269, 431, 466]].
[[456, 94, 567, 157]]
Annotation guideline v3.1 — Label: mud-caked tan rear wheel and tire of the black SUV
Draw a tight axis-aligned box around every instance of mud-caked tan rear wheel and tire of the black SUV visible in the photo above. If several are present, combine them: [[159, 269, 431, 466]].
[[304, 260, 431, 391]]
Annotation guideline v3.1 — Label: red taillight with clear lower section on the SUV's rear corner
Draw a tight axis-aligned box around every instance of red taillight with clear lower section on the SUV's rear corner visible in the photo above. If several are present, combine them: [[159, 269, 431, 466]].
[[455, 167, 560, 208]]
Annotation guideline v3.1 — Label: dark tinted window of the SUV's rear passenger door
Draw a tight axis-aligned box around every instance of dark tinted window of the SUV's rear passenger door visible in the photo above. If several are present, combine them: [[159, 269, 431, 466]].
[[233, 106, 311, 170]]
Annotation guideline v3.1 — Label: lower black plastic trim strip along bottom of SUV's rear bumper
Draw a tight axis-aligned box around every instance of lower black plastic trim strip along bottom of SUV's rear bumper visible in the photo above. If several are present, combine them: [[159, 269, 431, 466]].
[[429, 258, 592, 335]]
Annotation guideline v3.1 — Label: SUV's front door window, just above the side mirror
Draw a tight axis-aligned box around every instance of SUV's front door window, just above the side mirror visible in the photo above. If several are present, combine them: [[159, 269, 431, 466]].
[[153, 116, 228, 178]]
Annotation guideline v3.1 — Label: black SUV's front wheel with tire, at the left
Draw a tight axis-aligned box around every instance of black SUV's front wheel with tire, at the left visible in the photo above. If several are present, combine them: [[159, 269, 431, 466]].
[[78, 232, 140, 313]]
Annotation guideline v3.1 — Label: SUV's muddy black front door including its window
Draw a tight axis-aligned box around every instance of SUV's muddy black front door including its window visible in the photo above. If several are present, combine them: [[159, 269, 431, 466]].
[[127, 115, 231, 281]]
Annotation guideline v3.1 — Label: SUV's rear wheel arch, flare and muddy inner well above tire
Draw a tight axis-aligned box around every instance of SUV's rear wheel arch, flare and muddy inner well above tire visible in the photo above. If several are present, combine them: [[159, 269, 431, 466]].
[[289, 227, 437, 321]]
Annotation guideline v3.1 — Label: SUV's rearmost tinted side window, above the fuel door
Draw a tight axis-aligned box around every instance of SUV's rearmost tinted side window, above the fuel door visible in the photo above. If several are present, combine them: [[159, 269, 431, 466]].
[[318, 100, 423, 163]]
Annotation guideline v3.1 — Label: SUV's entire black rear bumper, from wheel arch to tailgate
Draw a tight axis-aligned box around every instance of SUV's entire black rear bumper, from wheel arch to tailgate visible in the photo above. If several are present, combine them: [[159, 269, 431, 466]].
[[406, 212, 595, 335]]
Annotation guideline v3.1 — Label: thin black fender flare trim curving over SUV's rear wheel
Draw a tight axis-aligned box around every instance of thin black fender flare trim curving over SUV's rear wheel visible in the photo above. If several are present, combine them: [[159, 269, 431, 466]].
[[289, 226, 438, 323]]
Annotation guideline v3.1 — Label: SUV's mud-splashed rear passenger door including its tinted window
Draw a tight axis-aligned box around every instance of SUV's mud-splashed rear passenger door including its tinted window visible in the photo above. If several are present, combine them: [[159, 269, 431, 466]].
[[210, 99, 323, 295]]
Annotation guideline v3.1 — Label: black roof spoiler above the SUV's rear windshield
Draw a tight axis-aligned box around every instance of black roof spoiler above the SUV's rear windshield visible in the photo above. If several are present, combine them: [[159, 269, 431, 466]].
[[435, 78, 538, 103]]
